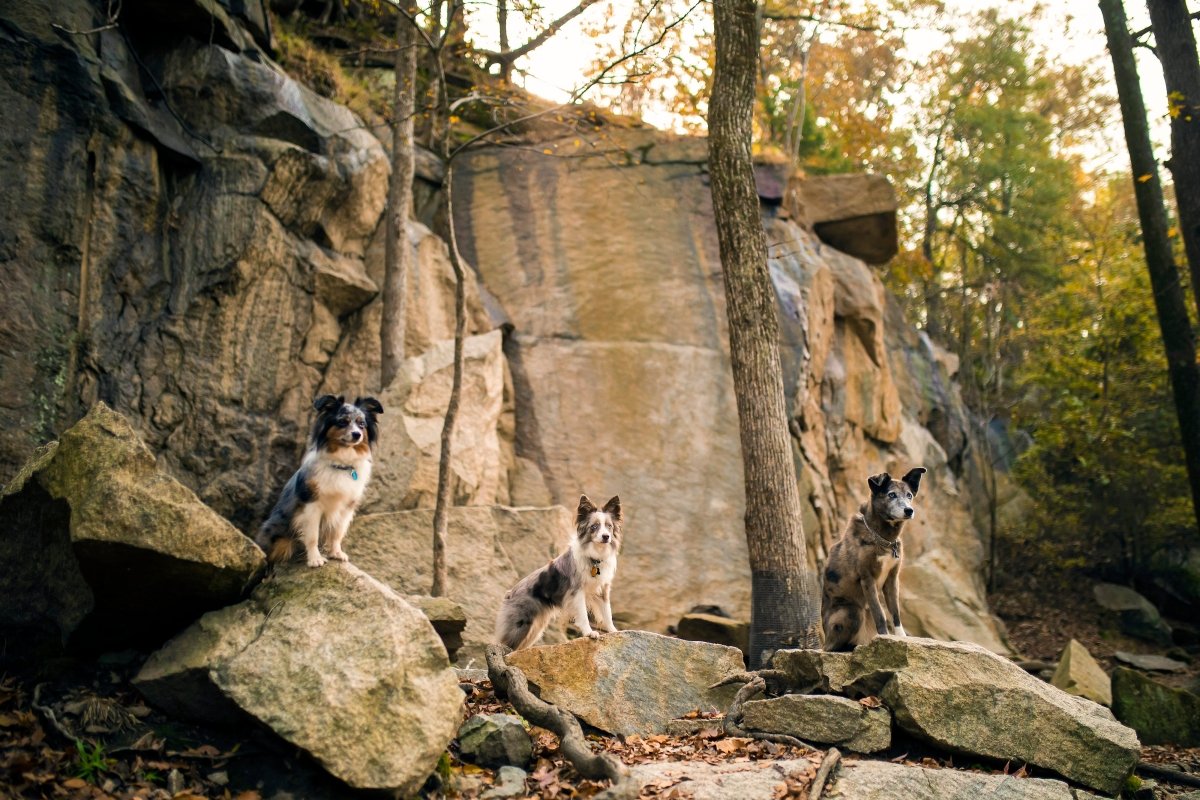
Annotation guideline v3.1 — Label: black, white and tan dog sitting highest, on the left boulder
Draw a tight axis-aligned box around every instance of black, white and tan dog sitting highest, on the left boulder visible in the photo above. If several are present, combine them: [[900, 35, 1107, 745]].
[[257, 395, 383, 566]]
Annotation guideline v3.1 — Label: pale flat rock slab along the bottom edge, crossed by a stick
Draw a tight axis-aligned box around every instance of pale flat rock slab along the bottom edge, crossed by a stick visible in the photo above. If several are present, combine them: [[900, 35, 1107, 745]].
[[631, 758, 1096, 800]]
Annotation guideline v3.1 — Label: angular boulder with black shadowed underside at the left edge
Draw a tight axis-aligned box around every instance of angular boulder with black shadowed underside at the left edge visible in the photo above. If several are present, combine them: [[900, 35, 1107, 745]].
[[0, 403, 265, 648]]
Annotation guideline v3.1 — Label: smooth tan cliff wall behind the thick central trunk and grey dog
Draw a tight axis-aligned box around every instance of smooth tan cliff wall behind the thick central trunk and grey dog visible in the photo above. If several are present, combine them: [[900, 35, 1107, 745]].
[[455, 131, 1007, 651]]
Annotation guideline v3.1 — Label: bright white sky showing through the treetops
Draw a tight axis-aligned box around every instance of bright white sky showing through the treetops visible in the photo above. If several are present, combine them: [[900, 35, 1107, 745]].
[[470, 0, 1166, 163]]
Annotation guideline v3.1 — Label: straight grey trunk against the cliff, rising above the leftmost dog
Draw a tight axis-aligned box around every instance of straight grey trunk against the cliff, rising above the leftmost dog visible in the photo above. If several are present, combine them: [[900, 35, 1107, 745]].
[[379, 6, 416, 389]]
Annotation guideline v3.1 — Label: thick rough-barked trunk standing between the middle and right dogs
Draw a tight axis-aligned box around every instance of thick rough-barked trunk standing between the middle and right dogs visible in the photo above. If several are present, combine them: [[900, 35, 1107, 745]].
[[708, 0, 821, 668]]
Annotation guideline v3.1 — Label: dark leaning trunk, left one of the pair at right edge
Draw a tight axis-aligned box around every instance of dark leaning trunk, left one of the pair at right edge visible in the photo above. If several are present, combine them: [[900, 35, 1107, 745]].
[[1100, 0, 1200, 534]]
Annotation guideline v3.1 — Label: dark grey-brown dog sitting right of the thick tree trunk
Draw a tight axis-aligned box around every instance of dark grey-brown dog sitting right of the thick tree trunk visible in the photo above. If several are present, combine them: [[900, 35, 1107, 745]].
[[821, 467, 925, 650]]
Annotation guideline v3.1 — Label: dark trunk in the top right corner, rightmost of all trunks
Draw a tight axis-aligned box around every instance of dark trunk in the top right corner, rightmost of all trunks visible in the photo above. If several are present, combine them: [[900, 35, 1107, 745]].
[[1146, 0, 1200, 319]]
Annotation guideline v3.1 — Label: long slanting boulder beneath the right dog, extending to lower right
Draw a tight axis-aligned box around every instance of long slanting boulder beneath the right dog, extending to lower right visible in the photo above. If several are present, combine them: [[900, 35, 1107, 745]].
[[774, 636, 1140, 793]]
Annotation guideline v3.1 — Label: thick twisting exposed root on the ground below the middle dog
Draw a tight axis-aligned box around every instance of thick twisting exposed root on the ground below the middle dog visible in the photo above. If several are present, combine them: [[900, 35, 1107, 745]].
[[486, 644, 641, 800]]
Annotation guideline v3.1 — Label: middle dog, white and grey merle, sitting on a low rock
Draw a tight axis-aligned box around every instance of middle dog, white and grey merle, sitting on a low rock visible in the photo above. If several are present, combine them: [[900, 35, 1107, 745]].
[[496, 494, 622, 650]]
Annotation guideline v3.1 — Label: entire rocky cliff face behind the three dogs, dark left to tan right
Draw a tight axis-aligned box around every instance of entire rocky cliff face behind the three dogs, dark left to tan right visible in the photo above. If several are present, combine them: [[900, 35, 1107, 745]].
[[0, 0, 1003, 649]]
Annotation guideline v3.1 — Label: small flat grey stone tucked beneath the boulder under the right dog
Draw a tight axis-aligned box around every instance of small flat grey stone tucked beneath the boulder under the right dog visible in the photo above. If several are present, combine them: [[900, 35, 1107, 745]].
[[742, 694, 892, 753]]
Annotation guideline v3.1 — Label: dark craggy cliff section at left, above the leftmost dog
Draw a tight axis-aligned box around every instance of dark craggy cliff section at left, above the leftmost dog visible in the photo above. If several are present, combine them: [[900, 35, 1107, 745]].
[[0, 0, 492, 533]]
